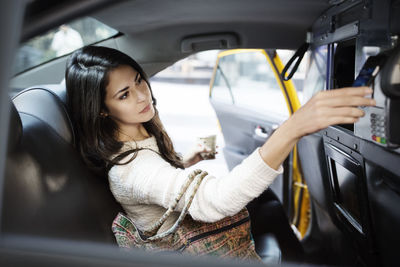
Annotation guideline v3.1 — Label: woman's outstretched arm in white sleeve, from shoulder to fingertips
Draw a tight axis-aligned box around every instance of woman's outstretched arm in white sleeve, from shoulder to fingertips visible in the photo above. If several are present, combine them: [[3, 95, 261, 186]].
[[109, 87, 375, 222]]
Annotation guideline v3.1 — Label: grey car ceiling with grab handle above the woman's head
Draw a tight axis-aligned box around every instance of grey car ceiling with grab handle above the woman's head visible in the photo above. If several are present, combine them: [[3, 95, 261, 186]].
[[11, 0, 335, 91]]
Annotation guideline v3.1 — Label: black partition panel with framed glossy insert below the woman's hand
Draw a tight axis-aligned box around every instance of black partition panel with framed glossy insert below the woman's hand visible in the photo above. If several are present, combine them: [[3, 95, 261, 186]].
[[323, 127, 378, 266]]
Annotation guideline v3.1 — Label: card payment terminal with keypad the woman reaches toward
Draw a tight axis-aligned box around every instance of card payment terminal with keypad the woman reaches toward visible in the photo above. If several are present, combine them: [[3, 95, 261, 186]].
[[353, 46, 400, 149]]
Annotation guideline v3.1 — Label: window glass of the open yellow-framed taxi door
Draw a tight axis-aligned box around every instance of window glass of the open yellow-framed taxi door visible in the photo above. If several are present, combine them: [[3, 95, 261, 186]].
[[211, 51, 289, 117]]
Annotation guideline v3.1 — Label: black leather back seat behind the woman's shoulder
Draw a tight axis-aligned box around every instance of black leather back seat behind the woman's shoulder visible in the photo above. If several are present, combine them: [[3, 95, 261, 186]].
[[1, 85, 122, 245]]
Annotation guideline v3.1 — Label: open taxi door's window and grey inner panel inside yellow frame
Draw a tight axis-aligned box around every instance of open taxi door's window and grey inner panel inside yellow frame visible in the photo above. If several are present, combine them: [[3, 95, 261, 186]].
[[210, 49, 294, 207]]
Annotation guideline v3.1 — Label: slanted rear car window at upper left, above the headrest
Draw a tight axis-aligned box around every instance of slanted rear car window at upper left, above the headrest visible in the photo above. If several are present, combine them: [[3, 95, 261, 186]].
[[13, 17, 118, 74]]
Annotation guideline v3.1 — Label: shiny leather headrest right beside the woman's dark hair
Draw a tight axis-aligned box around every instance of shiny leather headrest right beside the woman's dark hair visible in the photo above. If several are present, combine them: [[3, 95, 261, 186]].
[[13, 84, 75, 144]]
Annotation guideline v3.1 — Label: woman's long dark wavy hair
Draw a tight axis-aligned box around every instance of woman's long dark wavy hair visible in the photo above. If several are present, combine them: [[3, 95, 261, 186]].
[[65, 46, 184, 175]]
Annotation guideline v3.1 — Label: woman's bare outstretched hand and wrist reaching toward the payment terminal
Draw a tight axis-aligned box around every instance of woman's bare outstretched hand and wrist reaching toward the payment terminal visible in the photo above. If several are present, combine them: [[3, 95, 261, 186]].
[[259, 87, 376, 169]]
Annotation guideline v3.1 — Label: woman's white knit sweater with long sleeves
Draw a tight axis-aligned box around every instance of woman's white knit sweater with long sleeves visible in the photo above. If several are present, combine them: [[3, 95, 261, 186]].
[[108, 136, 283, 232]]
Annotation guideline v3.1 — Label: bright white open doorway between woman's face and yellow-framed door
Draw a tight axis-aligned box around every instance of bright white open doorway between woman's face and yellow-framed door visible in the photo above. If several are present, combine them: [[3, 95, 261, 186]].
[[150, 50, 229, 176]]
